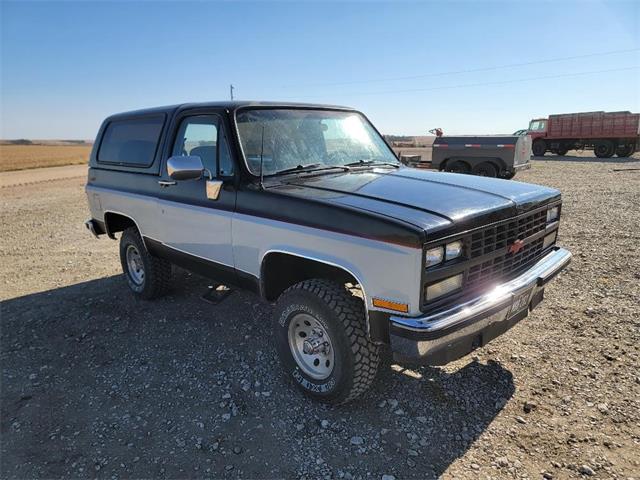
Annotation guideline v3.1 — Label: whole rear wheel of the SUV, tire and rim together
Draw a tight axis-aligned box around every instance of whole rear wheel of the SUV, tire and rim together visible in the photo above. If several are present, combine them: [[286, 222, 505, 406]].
[[120, 227, 171, 300]]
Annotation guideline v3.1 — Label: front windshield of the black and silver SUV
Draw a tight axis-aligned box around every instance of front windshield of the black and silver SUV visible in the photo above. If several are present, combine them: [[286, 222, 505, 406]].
[[236, 109, 400, 175]]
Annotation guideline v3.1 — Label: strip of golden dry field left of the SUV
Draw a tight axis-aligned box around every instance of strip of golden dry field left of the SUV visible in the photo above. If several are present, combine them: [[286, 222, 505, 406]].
[[0, 142, 91, 172]]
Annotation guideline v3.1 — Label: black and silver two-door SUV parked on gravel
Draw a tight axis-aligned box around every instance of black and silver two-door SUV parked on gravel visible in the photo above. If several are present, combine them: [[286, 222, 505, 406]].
[[86, 102, 571, 404]]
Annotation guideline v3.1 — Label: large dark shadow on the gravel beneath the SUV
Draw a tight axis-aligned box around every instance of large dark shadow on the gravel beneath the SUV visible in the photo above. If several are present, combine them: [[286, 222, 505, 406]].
[[0, 271, 514, 478]]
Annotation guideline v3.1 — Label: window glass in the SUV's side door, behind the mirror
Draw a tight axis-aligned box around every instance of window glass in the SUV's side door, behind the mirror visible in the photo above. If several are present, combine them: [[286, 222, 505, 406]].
[[172, 115, 233, 177]]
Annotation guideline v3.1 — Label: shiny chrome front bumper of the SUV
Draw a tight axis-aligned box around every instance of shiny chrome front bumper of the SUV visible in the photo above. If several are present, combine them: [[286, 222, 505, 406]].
[[389, 247, 572, 365]]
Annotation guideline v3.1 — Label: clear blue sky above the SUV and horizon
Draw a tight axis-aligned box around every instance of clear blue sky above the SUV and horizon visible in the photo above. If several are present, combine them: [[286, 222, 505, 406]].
[[0, 0, 640, 139]]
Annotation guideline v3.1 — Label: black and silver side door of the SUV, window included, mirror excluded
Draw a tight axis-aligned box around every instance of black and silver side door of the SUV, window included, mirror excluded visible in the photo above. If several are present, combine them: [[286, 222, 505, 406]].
[[158, 113, 236, 281]]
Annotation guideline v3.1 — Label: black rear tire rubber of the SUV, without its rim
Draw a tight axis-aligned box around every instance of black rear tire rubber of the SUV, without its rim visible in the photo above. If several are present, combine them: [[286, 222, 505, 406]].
[[120, 227, 171, 300]]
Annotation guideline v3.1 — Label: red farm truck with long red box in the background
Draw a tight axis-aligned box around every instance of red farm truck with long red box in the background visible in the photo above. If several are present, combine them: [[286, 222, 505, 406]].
[[528, 112, 640, 158]]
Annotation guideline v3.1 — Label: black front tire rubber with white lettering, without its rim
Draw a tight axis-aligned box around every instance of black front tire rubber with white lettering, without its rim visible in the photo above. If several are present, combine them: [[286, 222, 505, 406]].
[[273, 279, 380, 405]]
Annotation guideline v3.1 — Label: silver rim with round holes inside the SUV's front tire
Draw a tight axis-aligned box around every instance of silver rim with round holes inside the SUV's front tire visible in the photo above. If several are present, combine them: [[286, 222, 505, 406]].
[[289, 313, 335, 380]]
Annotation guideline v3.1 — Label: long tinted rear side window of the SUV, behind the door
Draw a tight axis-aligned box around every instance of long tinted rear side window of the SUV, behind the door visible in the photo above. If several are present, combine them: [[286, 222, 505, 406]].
[[98, 115, 164, 167]]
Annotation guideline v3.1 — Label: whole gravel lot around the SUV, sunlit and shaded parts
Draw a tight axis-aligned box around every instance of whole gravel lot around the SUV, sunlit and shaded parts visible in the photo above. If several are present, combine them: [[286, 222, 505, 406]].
[[0, 157, 640, 479]]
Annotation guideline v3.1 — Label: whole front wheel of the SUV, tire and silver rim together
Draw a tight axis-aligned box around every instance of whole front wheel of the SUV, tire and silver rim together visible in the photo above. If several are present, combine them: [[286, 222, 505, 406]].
[[274, 279, 380, 405]]
